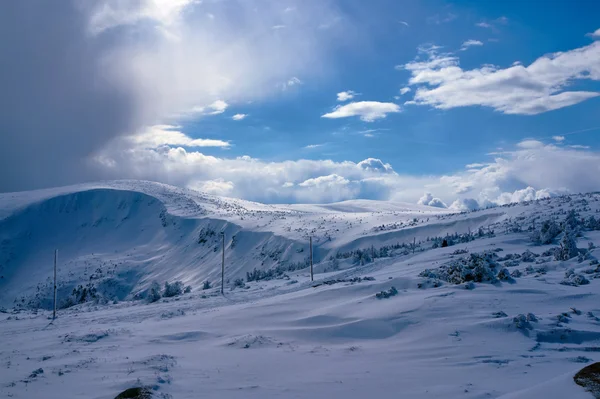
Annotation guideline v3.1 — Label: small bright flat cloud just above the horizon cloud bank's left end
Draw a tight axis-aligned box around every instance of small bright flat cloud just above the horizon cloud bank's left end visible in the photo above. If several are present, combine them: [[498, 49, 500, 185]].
[[128, 125, 231, 148]]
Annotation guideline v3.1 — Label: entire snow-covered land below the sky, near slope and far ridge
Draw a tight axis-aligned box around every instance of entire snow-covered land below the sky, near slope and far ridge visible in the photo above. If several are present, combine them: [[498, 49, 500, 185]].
[[0, 181, 600, 399]]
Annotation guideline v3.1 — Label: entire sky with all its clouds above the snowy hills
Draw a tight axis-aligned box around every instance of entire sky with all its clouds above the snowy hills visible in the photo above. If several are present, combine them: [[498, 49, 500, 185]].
[[0, 0, 600, 210]]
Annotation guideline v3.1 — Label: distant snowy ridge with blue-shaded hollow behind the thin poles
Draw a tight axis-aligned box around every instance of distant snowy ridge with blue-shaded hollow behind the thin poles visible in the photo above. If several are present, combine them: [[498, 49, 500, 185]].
[[0, 181, 454, 308]]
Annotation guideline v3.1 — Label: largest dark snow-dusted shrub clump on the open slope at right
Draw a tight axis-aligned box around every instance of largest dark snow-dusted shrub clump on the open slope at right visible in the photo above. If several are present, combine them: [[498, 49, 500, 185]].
[[419, 253, 499, 284]]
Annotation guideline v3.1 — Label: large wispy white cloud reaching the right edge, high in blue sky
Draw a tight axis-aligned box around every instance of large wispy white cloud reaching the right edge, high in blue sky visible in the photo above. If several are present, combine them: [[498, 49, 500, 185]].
[[402, 41, 600, 115]]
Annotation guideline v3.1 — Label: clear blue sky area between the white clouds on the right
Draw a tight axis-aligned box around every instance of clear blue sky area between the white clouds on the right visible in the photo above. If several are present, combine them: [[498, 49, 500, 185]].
[[183, 1, 600, 174]]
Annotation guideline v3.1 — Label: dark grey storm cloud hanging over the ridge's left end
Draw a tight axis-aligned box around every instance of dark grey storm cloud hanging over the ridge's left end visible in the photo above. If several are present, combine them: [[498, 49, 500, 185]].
[[0, 0, 135, 192]]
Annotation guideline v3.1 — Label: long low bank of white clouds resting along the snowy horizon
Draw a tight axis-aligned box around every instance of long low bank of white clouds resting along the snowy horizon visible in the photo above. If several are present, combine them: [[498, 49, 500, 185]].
[[92, 134, 600, 209]]
